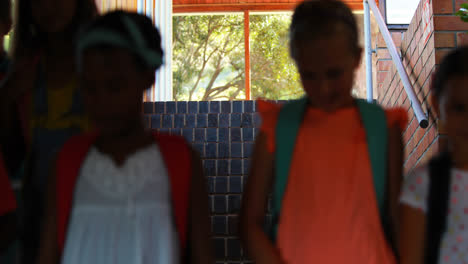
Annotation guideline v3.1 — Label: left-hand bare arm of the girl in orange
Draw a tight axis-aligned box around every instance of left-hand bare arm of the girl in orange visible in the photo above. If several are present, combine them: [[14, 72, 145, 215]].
[[240, 133, 283, 264]]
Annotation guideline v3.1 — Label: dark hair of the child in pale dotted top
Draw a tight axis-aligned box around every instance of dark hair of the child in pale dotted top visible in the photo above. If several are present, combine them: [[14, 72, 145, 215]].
[[431, 47, 468, 100]]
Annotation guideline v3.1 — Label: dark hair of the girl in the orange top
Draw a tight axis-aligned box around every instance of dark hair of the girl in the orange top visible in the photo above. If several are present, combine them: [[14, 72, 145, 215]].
[[290, 0, 360, 60]]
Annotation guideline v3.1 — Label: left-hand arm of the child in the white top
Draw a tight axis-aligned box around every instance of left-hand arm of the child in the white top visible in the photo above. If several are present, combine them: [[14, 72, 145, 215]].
[[37, 168, 60, 264]]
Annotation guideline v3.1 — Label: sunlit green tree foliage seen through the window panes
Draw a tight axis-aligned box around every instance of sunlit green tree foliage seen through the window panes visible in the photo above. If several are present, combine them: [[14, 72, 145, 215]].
[[173, 14, 303, 100]]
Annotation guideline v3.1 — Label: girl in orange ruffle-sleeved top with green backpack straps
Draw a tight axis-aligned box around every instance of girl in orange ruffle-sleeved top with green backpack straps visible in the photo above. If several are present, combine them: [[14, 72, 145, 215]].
[[241, 0, 406, 264]]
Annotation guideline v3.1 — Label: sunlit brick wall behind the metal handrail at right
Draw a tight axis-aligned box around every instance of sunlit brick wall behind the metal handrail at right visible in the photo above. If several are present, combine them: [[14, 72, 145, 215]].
[[376, 0, 468, 172]]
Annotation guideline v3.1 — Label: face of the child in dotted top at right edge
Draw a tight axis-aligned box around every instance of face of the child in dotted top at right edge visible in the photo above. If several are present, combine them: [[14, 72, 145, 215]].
[[439, 76, 468, 152]]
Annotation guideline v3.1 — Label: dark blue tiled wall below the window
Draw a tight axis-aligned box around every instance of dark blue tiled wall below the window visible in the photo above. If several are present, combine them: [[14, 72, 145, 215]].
[[144, 101, 260, 263]]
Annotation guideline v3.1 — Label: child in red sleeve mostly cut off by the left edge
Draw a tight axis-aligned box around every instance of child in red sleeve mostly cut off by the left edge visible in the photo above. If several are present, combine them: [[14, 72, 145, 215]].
[[0, 155, 17, 256]]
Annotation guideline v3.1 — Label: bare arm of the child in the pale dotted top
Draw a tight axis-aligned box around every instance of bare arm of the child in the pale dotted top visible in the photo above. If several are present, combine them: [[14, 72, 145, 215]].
[[399, 204, 426, 264]]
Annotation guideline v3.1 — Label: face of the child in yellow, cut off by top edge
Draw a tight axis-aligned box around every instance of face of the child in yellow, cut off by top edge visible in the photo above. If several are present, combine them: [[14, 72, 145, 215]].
[[30, 0, 77, 33]]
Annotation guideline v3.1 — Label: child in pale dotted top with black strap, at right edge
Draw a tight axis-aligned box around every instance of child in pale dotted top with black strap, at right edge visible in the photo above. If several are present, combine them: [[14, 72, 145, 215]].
[[401, 47, 468, 264]]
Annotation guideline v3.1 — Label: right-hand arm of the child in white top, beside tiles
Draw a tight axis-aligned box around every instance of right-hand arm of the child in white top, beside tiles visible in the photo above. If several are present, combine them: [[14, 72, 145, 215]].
[[189, 151, 214, 264]]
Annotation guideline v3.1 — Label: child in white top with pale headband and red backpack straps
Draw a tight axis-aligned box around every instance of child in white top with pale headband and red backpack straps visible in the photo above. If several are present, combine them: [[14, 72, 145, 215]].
[[39, 11, 212, 264]]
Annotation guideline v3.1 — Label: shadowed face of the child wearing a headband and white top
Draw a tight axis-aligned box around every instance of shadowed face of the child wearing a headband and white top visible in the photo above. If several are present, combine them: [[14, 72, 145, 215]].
[[80, 48, 154, 136]]
